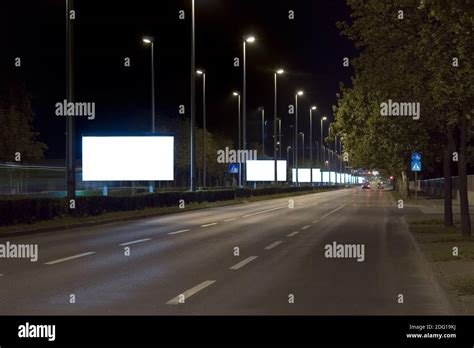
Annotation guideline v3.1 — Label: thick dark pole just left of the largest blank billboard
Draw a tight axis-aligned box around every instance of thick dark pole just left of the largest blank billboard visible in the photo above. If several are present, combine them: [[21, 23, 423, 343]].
[[66, 0, 76, 201]]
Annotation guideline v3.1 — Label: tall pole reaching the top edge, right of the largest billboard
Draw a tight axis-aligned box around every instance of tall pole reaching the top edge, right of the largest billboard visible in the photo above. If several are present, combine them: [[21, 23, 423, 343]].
[[189, 0, 196, 191]]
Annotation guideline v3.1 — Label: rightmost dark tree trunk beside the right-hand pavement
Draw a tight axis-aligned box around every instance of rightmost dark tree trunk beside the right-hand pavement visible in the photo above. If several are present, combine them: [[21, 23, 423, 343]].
[[458, 116, 471, 237]]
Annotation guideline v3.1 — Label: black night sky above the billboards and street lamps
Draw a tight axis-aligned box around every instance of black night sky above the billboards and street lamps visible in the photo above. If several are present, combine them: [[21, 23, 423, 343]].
[[0, 0, 355, 158]]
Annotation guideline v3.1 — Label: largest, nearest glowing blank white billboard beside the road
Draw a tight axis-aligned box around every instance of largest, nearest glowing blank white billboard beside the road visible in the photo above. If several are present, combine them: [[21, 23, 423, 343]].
[[82, 136, 174, 181]]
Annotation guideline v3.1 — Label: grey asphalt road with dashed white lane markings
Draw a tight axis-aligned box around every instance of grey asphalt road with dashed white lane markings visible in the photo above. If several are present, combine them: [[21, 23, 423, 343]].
[[0, 187, 451, 315]]
